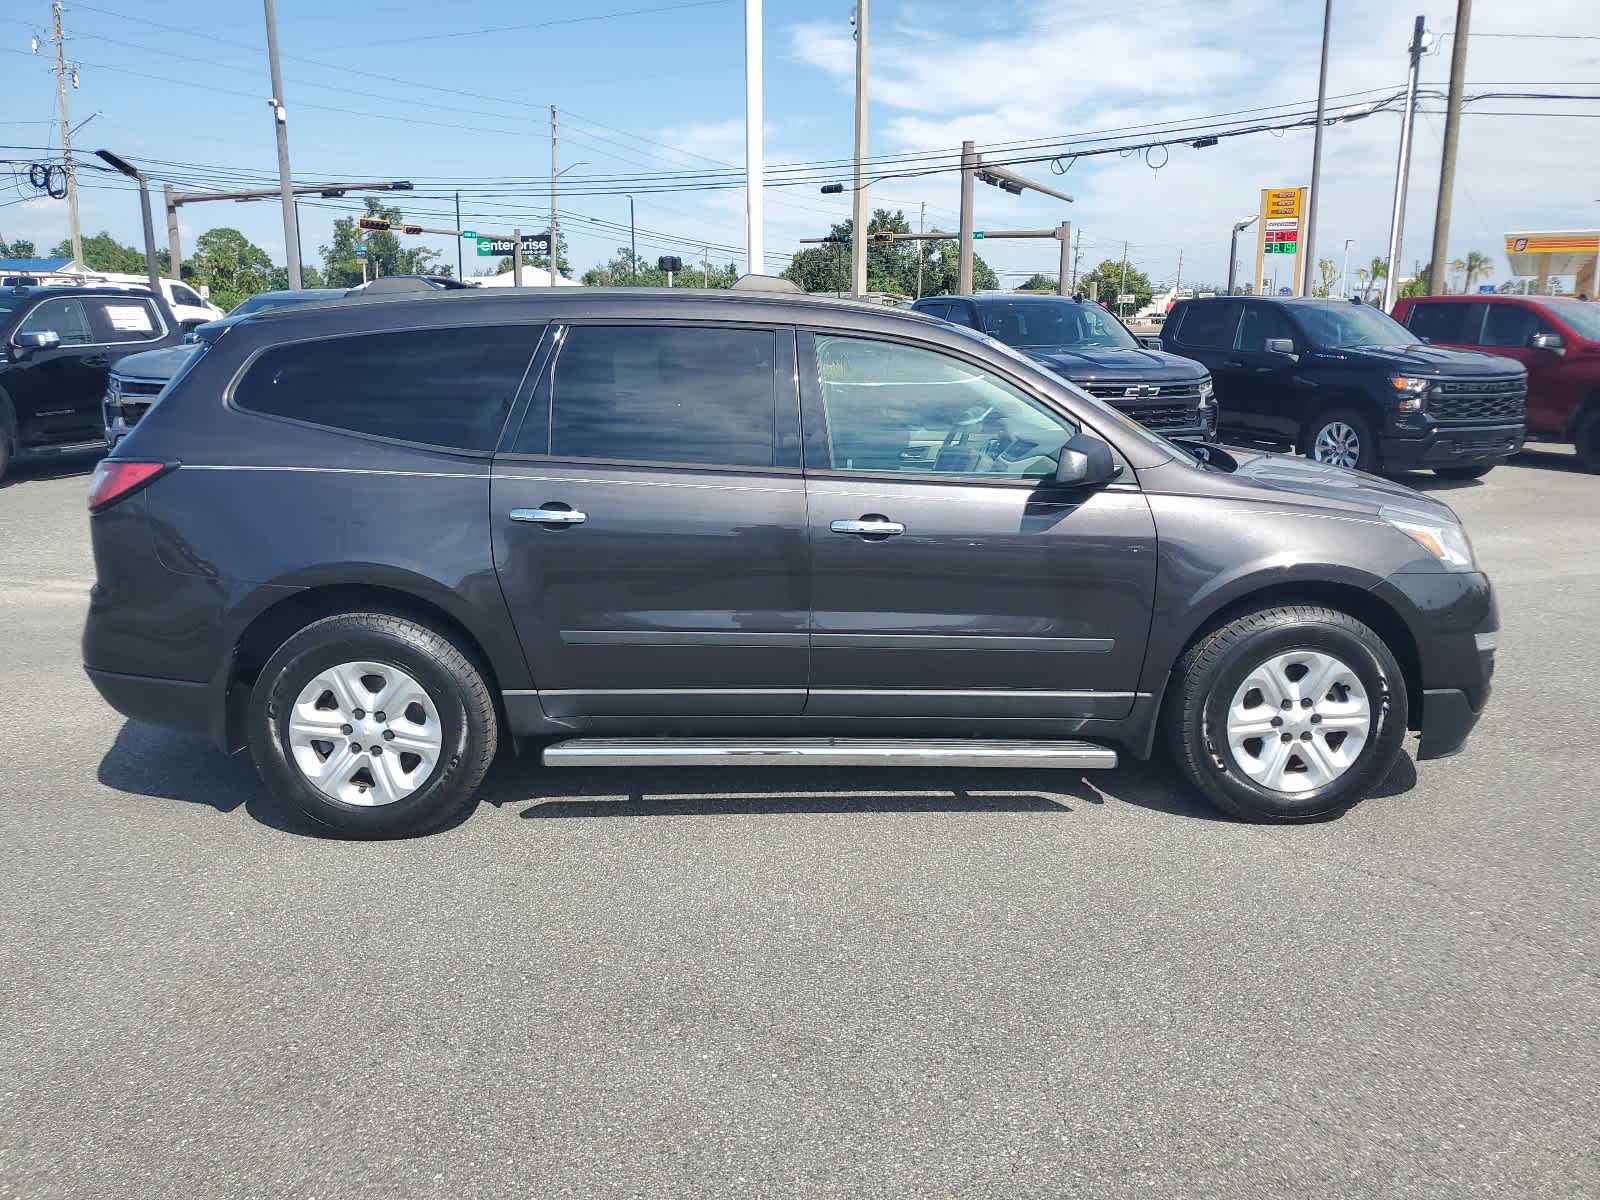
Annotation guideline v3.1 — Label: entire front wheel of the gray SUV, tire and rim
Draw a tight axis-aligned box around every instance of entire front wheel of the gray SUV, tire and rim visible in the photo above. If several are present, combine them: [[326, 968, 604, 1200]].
[[1165, 605, 1406, 822]]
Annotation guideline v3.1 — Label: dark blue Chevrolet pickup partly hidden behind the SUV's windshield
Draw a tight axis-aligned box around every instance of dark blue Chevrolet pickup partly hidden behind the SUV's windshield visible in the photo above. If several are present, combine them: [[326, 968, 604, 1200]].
[[914, 293, 1216, 440]]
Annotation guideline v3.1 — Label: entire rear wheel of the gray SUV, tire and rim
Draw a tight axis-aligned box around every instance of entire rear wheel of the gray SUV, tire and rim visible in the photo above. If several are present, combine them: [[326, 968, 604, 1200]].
[[250, 613, 498, 838]]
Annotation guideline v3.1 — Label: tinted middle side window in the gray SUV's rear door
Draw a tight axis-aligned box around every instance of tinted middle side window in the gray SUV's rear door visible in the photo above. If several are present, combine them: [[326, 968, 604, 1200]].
[[550, 325, 778, 467]]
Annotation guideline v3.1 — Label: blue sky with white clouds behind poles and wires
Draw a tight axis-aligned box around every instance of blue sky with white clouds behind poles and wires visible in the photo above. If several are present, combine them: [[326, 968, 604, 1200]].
[[0, 0, 1600, 289]]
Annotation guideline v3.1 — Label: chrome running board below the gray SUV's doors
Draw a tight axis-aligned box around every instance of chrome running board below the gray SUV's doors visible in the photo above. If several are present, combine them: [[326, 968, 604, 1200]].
[[542, 738, 1117, 770]]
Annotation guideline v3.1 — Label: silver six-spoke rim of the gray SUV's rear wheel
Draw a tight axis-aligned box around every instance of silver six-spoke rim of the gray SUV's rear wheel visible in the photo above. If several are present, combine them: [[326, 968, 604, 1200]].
[[288, 662, 445, 806]]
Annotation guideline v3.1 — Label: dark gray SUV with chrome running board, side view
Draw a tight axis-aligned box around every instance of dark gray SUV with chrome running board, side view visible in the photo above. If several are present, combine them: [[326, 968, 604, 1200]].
[[83, 290, 1496, 835]]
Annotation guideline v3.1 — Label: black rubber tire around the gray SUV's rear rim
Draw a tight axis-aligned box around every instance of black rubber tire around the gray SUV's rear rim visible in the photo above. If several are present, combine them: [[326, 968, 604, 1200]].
[[248, 613, 498, 838]]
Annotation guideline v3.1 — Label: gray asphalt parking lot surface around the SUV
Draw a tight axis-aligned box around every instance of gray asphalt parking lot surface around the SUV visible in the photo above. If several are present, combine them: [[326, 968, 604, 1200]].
[[0, 450, 1600, 1198]]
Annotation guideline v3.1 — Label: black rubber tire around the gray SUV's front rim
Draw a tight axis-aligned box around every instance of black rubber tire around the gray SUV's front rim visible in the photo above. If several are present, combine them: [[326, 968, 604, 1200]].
[[1165, 605, 1408, 822]]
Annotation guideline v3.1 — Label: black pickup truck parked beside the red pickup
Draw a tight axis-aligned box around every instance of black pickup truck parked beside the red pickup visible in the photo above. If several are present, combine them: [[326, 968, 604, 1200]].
[[1162, 296, 1528, 478]]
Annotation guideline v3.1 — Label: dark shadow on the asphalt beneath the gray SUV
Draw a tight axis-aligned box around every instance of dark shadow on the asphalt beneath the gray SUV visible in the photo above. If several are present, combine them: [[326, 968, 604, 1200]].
[[98, 720, 1416, 838]]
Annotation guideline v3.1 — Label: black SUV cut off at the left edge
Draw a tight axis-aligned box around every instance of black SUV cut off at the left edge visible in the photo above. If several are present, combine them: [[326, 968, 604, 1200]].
[[0, 286, 182, 477]]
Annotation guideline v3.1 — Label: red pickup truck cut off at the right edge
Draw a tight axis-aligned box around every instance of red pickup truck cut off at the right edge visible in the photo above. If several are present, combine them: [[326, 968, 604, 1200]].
[[1395, 296, 1600, 472]]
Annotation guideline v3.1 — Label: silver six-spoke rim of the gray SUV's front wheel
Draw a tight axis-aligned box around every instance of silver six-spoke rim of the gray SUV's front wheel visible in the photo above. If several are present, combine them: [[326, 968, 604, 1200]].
[[1227, 650, 1373, 795]]
